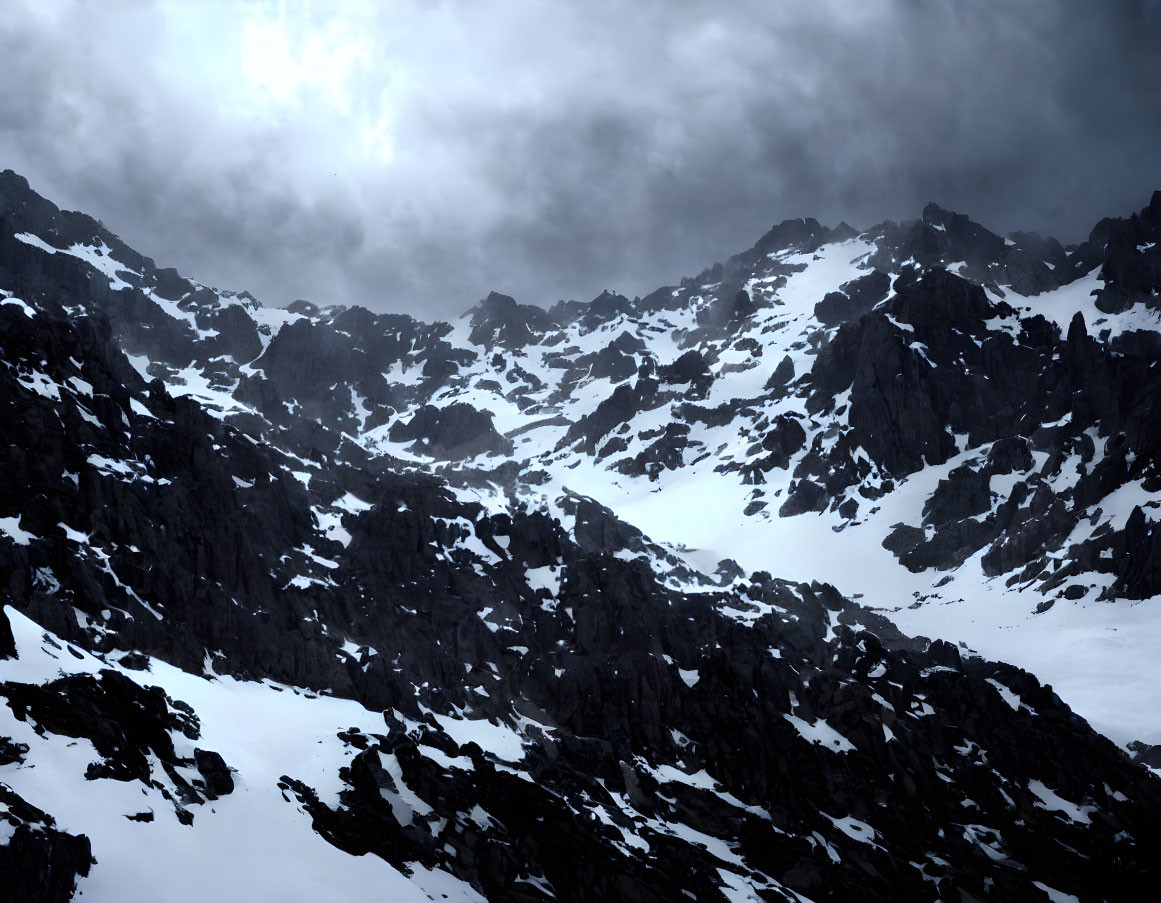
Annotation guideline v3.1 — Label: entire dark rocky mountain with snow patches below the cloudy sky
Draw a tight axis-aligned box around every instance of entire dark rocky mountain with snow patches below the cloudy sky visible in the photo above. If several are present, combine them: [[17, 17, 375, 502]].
[[0, 172, 1161, 901]]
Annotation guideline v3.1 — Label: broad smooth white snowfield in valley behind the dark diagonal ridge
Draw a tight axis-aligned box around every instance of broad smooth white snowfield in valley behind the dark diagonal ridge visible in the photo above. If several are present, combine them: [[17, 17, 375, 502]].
[[541, 417, 1161, 744]]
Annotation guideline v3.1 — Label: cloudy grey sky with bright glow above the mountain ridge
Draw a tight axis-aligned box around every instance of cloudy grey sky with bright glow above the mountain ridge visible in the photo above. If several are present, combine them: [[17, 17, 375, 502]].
[[0, 0, 1161, 318]]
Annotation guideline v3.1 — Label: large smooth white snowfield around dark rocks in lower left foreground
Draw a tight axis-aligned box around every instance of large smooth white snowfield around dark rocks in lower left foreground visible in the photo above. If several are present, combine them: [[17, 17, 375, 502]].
[[0, 607, 483, 903]]
